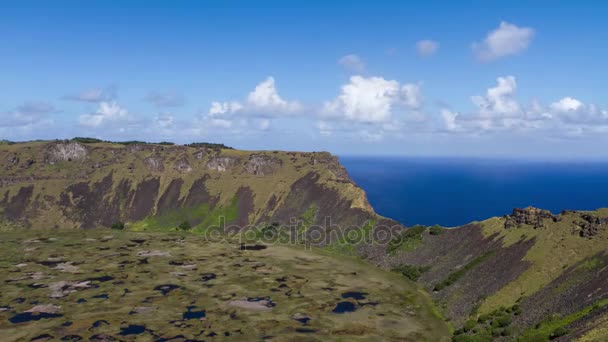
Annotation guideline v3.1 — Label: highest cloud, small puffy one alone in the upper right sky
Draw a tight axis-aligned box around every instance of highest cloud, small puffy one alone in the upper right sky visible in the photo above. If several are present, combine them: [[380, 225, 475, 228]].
[[473, 21, 534, 62]]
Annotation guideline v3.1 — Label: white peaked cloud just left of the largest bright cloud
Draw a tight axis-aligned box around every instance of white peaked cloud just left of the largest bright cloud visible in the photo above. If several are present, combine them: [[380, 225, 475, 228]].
[[203, 77, 302, 130]]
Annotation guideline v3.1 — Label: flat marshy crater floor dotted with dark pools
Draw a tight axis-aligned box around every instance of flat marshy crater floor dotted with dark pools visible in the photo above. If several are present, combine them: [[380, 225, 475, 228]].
[[0, 229, 450, 341]]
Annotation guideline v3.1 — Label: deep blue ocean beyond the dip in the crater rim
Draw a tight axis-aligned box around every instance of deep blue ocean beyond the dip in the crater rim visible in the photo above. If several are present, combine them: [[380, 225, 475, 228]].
[[340, 157, 608, 227]]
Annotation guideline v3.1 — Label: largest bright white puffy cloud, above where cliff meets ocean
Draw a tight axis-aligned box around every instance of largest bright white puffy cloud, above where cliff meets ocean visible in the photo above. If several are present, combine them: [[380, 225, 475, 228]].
[[323, 76, 422, 123]]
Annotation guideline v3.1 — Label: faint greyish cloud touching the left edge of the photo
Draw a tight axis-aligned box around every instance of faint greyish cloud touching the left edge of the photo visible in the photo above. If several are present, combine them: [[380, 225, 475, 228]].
[[0, 101, 56, 128]]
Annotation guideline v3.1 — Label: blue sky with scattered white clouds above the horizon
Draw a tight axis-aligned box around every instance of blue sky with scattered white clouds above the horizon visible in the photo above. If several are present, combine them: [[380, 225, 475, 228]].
[[0, 0, 608, 160]]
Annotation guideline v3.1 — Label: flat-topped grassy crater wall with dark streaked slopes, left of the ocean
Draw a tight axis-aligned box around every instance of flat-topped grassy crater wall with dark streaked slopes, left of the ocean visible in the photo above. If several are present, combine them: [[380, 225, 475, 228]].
[[0, 141, 375, 230]]
